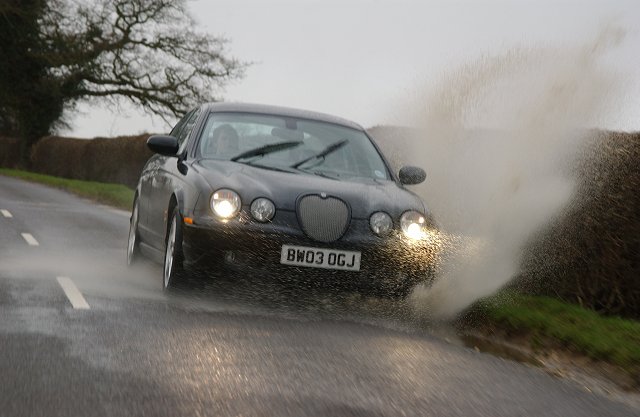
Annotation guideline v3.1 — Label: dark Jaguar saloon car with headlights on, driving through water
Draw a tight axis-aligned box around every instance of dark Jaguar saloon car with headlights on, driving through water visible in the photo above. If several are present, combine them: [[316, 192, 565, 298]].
[[127, 103, 437, 295]]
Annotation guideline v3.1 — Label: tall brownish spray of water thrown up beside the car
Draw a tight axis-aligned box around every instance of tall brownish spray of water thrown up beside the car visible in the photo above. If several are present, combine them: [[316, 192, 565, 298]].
[[402, 28, 624, 318]]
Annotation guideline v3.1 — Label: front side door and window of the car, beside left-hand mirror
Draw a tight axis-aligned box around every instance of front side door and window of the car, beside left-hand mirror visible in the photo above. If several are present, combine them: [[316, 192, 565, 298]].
[[149, 109, 200, 249]]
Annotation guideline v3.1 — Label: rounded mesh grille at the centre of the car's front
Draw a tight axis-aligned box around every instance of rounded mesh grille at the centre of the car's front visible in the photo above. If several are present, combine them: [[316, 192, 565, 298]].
[[298, 194, 351, 242]]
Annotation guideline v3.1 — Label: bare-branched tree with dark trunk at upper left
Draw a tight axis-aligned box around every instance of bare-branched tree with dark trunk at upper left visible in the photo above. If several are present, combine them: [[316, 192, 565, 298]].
[[0, 0, 244, 166]]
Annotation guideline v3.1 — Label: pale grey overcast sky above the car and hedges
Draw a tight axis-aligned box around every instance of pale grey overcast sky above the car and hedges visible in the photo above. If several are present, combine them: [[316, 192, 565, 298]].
[[67, 0, 640, 138]]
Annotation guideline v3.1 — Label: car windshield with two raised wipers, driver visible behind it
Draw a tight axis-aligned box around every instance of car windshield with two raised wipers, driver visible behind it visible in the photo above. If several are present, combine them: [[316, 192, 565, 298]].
[[197, 113, 390, 180]]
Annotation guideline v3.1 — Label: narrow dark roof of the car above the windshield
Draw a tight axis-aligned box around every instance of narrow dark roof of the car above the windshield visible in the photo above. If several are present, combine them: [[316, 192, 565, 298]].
[[205, 103, 364, 130]]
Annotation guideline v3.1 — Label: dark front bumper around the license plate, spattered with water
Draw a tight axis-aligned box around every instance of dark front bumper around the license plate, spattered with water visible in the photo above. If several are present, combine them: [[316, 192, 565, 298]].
[[183, 211, 438, 286]]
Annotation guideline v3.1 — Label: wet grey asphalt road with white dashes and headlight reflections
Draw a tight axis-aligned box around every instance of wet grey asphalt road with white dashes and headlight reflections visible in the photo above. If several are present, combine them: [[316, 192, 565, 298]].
[[0, 177, 640, 417]]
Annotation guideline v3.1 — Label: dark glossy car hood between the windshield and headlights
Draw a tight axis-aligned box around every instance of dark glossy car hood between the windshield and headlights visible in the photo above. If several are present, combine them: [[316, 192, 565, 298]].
[[193, 160, 425, 218]]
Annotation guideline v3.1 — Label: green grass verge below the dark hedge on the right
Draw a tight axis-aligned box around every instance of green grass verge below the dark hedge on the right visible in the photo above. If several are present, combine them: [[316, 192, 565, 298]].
[[481, 293, 640, 376]]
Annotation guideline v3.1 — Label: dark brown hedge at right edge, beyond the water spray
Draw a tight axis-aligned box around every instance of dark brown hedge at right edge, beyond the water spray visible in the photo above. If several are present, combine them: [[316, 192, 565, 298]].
[[520, 132, 640, 318]]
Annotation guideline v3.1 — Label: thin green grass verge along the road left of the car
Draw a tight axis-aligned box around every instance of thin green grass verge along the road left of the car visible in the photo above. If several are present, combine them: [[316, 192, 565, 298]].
[[0, 168, 134, 210]]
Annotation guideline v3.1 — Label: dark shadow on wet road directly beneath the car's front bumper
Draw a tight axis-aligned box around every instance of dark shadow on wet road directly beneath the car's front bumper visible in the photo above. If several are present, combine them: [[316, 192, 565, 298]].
[[158, 269, 428, 332]]
